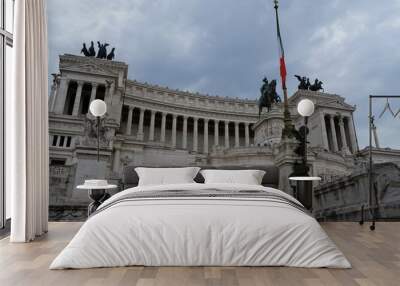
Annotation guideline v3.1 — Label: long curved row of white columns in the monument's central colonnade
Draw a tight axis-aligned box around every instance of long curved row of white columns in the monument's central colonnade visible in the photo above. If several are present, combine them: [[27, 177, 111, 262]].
[[125, 105, 250, 153]]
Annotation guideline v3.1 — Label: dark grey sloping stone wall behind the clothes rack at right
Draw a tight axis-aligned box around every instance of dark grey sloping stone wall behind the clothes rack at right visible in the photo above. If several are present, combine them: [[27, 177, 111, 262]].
[[313, 163, 400, 221]]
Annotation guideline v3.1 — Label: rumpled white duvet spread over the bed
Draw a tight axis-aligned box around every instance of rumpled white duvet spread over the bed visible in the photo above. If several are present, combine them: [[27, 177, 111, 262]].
[[50, 183, 351, 269]]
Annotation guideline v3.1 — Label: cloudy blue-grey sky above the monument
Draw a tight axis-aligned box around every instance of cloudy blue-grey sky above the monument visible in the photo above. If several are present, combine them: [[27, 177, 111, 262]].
[[47, 0, 400, 148]]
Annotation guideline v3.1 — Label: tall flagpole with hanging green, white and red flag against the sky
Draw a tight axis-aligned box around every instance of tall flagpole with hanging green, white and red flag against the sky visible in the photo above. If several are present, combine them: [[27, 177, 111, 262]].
[[274, 0, 294, 138]]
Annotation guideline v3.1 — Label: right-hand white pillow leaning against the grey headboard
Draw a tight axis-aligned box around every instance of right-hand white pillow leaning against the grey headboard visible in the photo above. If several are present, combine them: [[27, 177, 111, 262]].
[[200, 170, 265, 185]]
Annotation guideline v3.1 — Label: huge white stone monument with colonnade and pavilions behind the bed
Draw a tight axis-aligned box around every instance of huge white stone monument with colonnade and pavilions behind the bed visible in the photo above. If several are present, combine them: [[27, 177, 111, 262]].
[[49, 51, 400, 219]]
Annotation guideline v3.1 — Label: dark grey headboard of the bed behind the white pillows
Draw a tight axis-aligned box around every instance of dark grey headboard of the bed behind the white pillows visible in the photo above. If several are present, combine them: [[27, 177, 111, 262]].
[[122, 166, 279, 190]]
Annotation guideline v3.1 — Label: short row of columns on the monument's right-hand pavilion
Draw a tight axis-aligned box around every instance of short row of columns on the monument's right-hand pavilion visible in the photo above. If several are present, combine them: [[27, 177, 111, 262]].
[[322, 114, 357, 152]]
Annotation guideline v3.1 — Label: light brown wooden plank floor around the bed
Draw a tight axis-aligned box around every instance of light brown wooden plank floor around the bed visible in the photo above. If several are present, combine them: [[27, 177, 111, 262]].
[[0, 222, 400, 286]]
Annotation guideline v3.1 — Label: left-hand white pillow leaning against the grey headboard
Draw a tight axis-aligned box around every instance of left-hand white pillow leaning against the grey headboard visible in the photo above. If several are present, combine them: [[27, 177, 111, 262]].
[[135, 167, 200, 186]]
